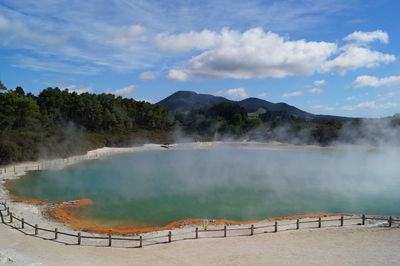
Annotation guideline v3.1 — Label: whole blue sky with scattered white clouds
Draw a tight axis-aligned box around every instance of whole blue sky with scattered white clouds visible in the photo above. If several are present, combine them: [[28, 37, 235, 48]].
[[0, 0, 400, 117]]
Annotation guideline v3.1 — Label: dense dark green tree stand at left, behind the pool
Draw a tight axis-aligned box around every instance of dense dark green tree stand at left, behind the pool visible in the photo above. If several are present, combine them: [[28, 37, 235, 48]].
[[0, 87, 174, 164]]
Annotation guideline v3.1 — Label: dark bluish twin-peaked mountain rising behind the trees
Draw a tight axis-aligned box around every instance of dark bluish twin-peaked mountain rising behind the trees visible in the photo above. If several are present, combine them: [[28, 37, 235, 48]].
[[158, 91, 313, 116]]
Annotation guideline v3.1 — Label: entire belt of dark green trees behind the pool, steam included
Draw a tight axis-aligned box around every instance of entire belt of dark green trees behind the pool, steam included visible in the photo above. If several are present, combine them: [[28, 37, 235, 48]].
[[0, 85, 400, 165]]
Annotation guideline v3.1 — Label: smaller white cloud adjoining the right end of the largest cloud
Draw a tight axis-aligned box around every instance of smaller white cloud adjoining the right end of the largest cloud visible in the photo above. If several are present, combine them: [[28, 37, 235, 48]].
[[322, 45, 396, 74]]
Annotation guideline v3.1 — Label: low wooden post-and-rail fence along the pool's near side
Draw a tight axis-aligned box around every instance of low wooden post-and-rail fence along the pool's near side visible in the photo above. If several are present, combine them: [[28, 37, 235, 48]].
[[0, 202, 400, 248]]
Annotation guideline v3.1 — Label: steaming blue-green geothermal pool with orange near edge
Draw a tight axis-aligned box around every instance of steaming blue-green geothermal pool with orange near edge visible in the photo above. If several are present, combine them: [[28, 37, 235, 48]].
[[9, 147, 400, 227]]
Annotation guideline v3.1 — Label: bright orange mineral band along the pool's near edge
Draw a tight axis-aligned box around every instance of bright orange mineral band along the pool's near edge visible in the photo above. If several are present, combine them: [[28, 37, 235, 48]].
[[12, 197, 347, 235]]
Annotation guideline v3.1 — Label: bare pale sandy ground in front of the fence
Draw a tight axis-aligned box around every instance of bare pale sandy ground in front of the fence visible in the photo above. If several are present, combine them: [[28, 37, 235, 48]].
[[0, 224, 400, 265]]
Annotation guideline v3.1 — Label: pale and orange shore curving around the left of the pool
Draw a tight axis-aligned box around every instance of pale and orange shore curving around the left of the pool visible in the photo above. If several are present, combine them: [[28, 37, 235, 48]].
[[0, 142, 384, 235]]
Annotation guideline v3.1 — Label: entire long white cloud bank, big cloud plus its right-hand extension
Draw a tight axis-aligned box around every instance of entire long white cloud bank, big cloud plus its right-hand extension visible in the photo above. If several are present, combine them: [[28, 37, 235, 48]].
[[164, 28, 396, 81]]
